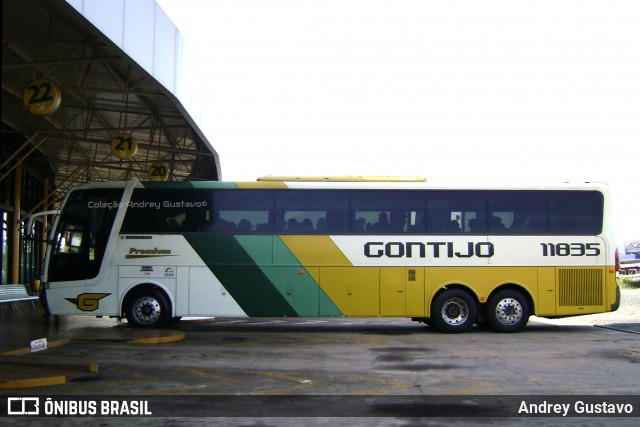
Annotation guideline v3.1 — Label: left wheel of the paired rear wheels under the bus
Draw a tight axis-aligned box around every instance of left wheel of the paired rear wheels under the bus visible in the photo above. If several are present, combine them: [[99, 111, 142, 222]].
[[431, 289, 478, 333]]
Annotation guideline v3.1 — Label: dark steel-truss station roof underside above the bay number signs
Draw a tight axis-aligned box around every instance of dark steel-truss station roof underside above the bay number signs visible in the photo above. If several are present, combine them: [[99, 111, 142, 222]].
[[0, 0, 220, 206]]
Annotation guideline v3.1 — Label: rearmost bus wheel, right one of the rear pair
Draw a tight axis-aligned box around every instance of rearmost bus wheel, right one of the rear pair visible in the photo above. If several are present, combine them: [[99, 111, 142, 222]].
[[487, 289, 531, 332]]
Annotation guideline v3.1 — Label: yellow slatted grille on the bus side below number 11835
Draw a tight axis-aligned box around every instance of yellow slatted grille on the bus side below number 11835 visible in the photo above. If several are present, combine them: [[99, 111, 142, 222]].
[[558, 268, 604, 306]]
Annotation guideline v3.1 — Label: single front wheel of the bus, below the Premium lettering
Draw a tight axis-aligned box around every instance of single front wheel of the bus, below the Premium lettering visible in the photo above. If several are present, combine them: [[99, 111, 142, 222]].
[[125, 288, 171, 328]]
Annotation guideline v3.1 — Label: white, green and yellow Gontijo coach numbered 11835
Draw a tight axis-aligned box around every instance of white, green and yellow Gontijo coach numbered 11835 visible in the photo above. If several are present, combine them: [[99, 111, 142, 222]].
[[41, 177, 620, 333]]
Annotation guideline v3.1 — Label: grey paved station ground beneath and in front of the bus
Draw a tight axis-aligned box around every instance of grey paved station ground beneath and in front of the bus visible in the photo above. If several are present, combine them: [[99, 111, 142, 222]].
[[0, 289, 640, 425]]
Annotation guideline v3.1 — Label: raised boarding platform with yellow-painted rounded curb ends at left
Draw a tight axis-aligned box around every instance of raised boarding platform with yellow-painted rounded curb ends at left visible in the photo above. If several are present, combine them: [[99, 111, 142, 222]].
[[0, 301, 184, 390]]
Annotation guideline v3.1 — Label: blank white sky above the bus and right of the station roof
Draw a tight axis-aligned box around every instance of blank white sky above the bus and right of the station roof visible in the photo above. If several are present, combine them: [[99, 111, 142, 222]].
[[157, 0, 640, 247]]
